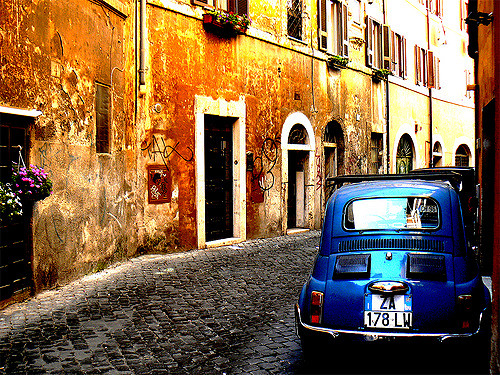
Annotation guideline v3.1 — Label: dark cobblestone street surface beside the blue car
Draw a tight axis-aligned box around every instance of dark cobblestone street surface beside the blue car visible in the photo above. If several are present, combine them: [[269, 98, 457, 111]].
[[0, 231, 319, 374]]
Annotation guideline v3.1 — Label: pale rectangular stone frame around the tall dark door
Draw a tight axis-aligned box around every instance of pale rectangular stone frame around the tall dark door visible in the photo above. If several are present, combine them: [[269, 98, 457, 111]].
[[194, 95, 246, 249]]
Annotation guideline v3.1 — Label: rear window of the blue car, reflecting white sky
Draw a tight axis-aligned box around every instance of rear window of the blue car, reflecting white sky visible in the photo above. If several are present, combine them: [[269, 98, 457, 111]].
[[344, 197, 441, 230]]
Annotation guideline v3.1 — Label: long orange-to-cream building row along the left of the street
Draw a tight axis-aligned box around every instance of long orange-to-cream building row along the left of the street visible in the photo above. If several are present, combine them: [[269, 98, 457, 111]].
[[0, 0, 475, 306]]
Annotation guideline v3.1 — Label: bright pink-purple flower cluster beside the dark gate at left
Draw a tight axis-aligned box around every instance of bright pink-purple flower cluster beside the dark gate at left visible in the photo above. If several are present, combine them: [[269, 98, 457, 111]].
[[12, 164, 52, 201]]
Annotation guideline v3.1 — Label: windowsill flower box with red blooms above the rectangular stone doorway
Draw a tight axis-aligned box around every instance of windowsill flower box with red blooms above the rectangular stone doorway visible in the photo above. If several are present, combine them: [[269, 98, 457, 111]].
[[203, 10, 251, 37]]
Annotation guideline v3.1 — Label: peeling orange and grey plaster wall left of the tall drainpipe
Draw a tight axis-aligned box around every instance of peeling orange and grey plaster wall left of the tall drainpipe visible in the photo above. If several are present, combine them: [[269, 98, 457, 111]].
[[0, 0, 138, 291]]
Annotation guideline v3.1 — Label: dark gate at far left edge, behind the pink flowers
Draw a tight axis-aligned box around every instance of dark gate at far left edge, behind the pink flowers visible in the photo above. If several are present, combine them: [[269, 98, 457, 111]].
[[0, 114, 32, 306]]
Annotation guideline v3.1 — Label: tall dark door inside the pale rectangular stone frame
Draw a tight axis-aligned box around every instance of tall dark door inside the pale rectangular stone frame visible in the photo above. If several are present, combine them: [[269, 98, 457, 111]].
[[205, 115, 235, 241]]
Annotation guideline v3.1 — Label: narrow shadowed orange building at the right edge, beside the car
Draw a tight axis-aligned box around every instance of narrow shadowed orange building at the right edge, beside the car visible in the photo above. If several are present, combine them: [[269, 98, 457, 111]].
[[467, 0, 500, 374]]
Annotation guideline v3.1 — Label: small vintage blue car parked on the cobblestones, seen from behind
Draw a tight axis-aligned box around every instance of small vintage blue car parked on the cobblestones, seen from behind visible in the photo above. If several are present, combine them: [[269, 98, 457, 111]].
[[295, 172, 491, 354]]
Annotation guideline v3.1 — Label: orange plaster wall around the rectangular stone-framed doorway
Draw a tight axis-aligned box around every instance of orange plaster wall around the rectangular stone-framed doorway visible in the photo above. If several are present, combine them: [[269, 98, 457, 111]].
[[145, 1, 385, 242]]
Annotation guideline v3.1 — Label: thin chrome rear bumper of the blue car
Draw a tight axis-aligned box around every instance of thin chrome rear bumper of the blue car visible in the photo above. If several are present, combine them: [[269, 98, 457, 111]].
[[295, 304, 488, 342]]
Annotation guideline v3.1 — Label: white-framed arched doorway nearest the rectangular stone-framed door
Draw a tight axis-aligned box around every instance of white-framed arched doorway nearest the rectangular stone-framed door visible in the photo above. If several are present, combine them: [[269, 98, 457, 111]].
[[281, 112, 315, 231]]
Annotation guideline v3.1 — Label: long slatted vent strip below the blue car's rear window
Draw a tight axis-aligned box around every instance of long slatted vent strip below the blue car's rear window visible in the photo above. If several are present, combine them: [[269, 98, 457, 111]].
[[339, 238, 444, 252]]
